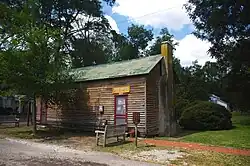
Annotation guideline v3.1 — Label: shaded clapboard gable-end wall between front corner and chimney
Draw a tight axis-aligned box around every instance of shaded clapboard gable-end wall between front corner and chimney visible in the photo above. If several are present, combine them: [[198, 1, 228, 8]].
[[146, 59, 161, 136]]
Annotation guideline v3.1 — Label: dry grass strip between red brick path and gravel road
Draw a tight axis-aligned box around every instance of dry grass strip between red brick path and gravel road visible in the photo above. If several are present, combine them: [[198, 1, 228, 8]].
[[96, 143, 250, 166]]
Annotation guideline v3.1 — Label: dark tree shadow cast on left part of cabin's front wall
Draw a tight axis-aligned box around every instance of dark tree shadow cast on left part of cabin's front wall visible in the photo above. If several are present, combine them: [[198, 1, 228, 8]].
[[46, 84, 102, 136]]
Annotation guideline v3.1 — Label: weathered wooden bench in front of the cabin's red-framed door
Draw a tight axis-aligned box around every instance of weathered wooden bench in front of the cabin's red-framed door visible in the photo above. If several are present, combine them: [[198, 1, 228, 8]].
[[95, 124, 127, 147]]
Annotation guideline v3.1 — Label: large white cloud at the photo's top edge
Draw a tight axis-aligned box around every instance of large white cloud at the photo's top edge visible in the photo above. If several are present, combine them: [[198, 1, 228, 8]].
[[112, 0, 191, 30]]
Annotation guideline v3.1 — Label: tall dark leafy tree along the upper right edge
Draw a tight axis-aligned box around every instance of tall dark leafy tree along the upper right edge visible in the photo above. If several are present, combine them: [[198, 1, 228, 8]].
[[185, 0, 250, 111]]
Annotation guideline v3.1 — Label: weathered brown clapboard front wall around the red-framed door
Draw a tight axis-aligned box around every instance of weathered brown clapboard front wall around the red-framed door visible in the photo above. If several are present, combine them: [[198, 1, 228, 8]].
[[37, 76, 146, 134]]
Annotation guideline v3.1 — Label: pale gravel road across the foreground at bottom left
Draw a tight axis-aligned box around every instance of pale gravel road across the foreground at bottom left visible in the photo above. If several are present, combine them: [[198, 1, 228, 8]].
[[0, 138, 159, 166]]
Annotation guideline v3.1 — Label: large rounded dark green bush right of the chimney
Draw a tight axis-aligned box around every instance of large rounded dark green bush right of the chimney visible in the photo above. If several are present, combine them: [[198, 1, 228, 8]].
[[179, 101, 232, 130]]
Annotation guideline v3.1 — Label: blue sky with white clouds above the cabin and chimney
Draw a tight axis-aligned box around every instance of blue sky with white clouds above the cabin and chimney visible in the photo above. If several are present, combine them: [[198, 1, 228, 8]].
[[103, 0, 215, 66]]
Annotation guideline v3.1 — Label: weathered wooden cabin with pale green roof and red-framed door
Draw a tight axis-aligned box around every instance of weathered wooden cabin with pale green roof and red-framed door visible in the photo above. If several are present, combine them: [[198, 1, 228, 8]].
[[37, 55, 172, 136]]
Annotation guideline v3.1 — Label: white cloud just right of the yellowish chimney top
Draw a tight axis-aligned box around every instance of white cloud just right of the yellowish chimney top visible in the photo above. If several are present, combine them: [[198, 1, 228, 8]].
[[174, 34, 215, 66]]
